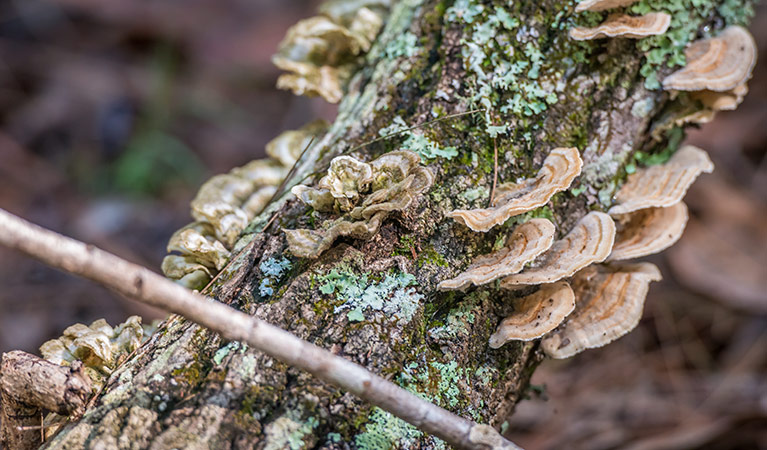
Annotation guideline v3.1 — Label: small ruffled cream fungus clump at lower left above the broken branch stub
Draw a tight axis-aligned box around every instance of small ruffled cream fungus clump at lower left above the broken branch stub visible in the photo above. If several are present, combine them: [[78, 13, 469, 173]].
[[40, 316, 152, 392]]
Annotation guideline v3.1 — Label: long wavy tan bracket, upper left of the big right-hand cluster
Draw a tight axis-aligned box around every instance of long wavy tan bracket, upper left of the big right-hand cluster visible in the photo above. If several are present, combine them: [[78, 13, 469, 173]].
[[448, 147, 583, 231]]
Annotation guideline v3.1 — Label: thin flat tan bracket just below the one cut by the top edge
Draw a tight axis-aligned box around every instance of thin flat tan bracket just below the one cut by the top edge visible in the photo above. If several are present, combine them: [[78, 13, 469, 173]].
[[570, 13, 671, 41]]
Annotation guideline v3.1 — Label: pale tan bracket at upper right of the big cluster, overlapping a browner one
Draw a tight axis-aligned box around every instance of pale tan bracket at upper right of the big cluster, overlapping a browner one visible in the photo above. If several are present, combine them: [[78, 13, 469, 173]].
[[609, 145, 714, 215]]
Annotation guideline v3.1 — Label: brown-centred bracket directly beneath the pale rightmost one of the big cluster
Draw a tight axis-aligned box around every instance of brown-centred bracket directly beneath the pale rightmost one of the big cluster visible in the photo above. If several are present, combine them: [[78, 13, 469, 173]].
[[608, 202, 687, 261]]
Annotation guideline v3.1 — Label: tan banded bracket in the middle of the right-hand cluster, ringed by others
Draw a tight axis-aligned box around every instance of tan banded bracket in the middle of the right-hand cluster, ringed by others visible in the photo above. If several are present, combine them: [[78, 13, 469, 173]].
[[501, 211, 615, 289]]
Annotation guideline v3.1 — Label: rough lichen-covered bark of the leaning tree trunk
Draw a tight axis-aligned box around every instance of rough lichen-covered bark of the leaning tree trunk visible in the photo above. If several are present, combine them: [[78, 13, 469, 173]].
[[39, 0, 750, 449]]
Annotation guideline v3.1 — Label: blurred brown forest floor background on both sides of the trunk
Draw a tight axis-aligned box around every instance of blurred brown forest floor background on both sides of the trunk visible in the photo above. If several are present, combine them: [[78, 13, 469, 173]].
[[0, 0, 767, 450]]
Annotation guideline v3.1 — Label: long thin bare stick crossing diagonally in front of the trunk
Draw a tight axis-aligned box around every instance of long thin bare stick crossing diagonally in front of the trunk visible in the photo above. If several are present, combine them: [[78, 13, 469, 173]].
[[0, 209, 519, 450]]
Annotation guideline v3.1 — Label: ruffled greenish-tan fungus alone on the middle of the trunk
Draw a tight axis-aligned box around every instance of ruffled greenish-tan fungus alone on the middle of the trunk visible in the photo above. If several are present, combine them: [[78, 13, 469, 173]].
[[285, 150, 434, 258]]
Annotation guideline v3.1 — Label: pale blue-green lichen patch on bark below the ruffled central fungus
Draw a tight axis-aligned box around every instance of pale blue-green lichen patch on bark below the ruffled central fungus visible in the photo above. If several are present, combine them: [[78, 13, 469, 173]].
[[319, 267, 423, 324]]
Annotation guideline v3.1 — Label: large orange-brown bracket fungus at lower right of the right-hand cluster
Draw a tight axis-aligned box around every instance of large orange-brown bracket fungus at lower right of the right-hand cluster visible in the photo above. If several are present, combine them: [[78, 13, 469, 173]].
[[541, 263, 662, 359]]
